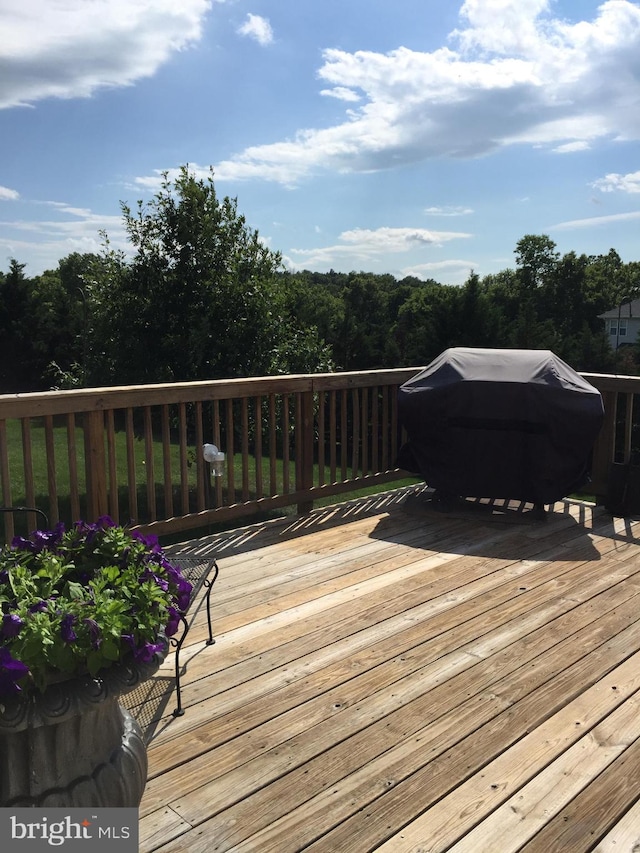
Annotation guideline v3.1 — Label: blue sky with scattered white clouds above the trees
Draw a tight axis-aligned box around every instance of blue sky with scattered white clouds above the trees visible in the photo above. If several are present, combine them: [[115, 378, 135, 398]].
[[0, 0, 640, 284]]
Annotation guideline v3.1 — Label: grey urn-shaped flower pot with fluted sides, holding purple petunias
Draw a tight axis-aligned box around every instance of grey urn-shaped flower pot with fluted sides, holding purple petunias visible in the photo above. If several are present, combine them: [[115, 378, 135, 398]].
[[0, 655, 162, 808]]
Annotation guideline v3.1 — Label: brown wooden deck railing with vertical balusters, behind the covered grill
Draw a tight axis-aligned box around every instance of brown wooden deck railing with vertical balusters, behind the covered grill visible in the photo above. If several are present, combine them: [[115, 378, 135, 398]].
[[0, 368, 640, 539]]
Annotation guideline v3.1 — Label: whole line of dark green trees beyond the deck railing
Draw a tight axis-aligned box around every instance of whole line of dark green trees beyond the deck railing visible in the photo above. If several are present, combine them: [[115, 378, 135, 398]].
[[0, 167, 640, 393]]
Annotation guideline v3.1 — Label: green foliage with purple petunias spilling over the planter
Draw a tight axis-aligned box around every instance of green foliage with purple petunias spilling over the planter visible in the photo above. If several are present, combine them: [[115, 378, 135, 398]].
[[0, 516, 191, 700]]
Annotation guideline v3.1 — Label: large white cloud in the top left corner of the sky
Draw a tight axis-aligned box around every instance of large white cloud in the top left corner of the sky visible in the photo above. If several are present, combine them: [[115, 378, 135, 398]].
[[0, 0, 211, 108]]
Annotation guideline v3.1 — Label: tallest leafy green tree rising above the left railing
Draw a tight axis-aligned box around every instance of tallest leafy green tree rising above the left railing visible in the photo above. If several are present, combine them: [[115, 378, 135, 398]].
[[94, 166, 325, 382]]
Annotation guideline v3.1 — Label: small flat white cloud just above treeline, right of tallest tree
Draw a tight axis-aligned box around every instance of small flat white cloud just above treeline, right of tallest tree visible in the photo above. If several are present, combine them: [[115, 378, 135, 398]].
[[289, 227, 471, 268]]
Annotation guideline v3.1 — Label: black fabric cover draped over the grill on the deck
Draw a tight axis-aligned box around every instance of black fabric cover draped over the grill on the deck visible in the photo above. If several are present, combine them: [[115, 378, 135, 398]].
[[398, 347, 604, 503]]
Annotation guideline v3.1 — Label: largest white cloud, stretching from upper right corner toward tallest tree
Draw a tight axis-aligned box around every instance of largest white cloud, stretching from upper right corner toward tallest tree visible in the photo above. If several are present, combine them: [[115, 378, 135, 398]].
[[174, 0, 640, 186]]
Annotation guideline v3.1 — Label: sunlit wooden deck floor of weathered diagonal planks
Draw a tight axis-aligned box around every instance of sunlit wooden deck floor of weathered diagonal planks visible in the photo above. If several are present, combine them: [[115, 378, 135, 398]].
[[127, 482, 640, 853]]
